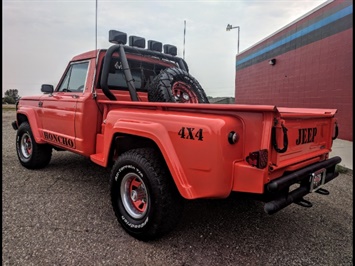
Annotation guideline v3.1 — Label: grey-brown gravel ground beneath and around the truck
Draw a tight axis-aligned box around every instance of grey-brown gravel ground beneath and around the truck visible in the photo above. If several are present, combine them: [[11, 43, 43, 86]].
[[2, 110, 353, 266]]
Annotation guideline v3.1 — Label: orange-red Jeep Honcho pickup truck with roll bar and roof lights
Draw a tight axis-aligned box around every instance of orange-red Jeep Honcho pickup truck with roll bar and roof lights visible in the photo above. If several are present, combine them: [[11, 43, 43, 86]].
[[12, 30, 341, 240]]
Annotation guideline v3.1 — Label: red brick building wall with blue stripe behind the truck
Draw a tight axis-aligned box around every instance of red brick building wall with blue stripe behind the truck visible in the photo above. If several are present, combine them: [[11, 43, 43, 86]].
[[235, 0, 353, 141]]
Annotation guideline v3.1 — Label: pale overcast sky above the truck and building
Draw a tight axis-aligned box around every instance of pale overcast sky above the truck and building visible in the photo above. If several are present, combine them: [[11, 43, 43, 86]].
[[2, 0, 326, 97]]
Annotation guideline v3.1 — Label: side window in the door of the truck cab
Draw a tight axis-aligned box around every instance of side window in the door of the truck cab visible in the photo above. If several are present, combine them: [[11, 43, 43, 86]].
[[58, 62, 89, 92]]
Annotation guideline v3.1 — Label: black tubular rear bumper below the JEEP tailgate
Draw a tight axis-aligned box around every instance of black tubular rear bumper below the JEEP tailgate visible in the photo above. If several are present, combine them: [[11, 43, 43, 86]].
[[264, 156, 341, 214]]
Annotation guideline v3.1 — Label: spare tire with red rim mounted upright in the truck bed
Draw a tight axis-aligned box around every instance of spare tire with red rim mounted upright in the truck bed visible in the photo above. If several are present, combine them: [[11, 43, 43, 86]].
[[148, 68, 208, 103]]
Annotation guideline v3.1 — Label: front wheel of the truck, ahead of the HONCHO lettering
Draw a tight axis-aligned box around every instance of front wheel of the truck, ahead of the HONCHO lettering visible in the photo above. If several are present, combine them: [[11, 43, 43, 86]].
[[16, 122, 52, 169]]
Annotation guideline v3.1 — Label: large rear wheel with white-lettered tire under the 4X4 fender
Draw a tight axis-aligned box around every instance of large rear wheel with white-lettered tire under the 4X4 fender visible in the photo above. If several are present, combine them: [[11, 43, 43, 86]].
[[110, 148, 183, 241]]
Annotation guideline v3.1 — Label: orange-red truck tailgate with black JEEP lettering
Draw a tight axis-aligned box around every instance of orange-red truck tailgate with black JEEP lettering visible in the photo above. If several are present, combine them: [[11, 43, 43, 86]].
[[271, 107, 336, 171]]
